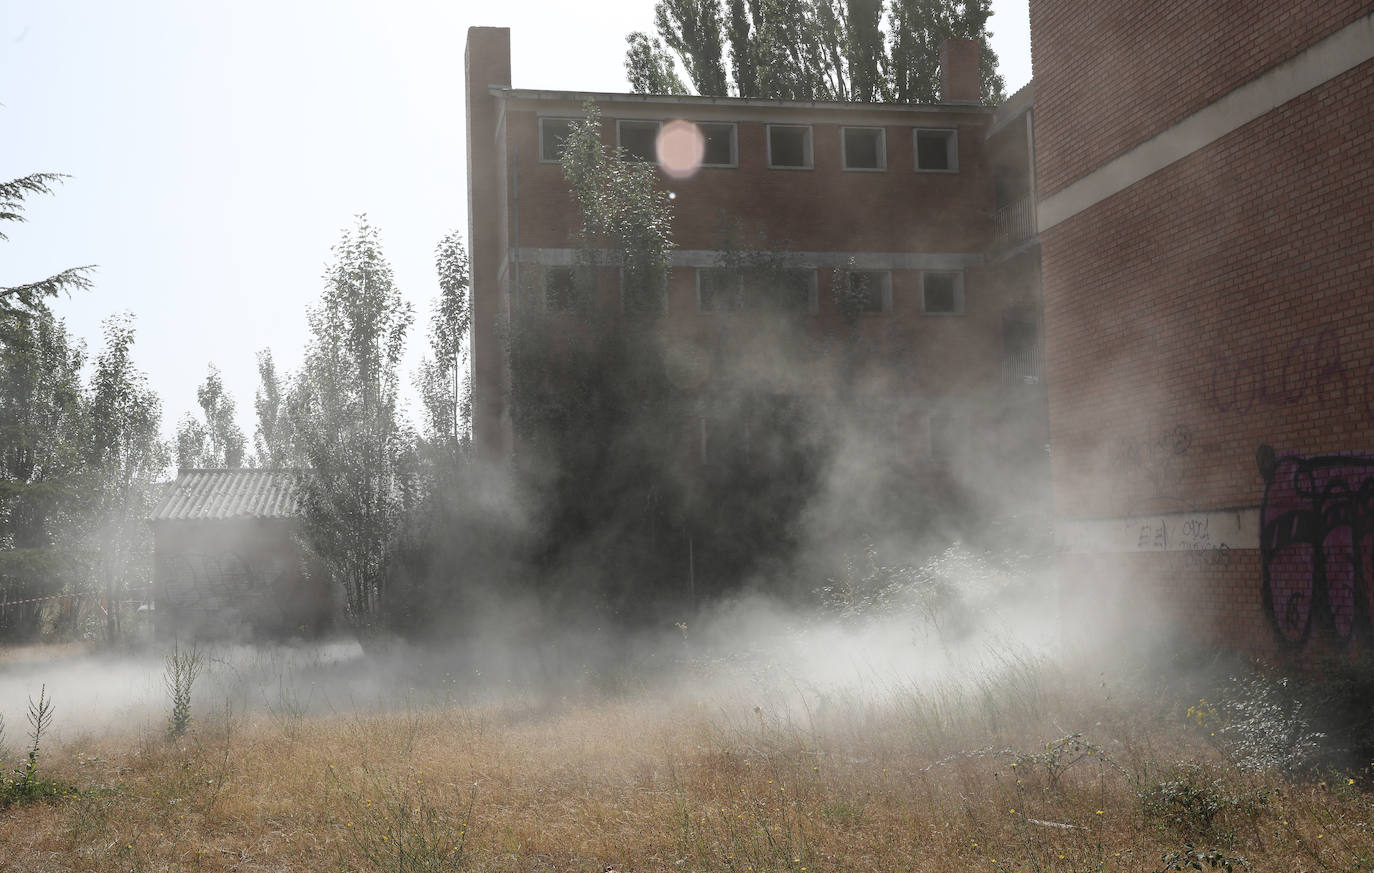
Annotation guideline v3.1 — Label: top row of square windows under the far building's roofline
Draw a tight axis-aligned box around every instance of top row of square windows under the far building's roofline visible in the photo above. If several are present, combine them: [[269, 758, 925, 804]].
[[539, 118, 959, 173]]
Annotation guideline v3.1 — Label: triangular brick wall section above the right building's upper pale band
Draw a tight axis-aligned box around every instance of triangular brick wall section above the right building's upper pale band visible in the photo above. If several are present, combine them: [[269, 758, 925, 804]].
[[1031, 0, 1370, 198]]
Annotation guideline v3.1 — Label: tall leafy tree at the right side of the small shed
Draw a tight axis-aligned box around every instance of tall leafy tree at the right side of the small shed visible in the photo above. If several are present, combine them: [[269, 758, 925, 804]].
[[294, 216, 415, 632]]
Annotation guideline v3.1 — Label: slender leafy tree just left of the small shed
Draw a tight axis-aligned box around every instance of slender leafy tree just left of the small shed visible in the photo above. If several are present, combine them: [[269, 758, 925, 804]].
[[82, 313, 168, 642]]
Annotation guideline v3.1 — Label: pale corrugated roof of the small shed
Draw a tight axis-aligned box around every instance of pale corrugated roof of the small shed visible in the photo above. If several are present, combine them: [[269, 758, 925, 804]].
[[148, 470, 297, 521]]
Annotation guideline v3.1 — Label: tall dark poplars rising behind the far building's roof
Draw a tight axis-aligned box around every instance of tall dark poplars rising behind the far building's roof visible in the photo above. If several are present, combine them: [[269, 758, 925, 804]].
[[625, 0, 1004, 104]]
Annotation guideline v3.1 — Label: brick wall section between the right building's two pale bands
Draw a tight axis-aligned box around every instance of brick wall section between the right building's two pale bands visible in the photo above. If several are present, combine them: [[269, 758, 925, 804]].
[[1043, 63, 1374, 517]]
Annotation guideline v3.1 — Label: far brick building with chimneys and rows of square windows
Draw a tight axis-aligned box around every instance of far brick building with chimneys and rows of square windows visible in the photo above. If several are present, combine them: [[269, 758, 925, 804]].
[[466, 27, 1047, 544]]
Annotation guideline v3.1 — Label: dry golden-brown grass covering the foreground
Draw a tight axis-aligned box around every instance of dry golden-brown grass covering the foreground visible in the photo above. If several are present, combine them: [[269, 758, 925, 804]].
[[0, 646, 1374, 873]]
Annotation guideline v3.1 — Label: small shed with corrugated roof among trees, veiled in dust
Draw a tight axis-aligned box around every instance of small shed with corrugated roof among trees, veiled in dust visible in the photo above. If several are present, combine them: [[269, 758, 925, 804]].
[[148, 469, 334, 639]]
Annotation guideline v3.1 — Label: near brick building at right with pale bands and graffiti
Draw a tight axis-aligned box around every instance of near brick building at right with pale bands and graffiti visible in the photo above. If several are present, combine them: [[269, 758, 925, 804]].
[[1031, 0, 1374, 652]]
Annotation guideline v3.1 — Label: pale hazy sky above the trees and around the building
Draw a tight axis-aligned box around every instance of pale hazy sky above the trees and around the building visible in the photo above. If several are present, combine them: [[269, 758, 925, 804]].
[[0, 0, 1031, 436]]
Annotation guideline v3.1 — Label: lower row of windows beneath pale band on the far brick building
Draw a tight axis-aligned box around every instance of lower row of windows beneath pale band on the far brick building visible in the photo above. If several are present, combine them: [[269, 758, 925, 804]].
[[544, 267, 963, 315]]
